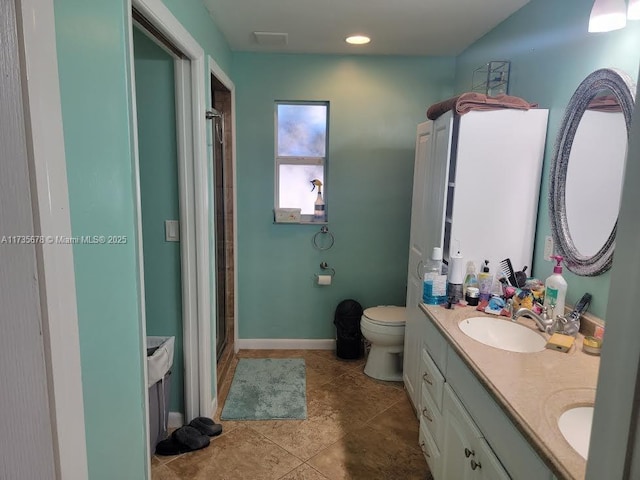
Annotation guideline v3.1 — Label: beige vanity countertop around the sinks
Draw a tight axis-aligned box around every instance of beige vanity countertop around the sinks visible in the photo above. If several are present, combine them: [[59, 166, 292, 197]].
[[421, 304, 600, 479]]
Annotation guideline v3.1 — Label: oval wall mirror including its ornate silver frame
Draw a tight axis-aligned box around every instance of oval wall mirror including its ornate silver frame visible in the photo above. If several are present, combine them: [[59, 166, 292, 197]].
[[549, 69, 635, 276]]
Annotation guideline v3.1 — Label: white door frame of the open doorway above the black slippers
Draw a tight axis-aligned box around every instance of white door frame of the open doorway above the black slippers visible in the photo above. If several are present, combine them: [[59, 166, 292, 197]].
[[127, 0, 213, 428]]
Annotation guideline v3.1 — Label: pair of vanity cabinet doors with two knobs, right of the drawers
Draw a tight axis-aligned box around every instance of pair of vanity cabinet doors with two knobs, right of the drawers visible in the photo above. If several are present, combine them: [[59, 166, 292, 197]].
[[442, 384, 510, 480]]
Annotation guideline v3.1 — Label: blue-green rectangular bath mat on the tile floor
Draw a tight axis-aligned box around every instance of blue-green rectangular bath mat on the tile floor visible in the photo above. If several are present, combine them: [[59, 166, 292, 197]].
[[221, 358, 307, 420]]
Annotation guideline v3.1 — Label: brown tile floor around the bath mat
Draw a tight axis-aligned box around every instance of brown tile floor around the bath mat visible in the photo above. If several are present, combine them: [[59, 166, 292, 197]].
[[151, 350, 432, 480]]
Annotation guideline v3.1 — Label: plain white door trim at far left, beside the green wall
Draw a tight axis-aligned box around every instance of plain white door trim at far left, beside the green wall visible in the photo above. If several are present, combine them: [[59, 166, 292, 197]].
[[15, 0, 88, 480]]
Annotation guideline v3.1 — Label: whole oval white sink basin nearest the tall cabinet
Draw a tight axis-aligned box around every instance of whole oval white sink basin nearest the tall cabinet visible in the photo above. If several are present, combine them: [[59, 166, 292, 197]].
[[458, 317, 547, 353]]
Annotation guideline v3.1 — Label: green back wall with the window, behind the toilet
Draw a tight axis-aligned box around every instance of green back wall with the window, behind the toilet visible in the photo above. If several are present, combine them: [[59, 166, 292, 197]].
[[233, 53, 454, 339]]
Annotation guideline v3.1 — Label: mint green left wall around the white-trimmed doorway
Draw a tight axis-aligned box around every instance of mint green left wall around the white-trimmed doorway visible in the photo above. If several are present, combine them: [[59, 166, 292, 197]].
[[54, 0, 231, 480]]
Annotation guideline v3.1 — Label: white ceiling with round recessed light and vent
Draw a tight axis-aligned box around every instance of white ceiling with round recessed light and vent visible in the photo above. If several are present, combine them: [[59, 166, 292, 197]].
[[203, 0, 529, 55]]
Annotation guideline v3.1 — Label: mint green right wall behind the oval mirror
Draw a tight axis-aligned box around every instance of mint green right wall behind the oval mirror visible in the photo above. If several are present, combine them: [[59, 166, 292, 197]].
[[455, 0, 640, 318]]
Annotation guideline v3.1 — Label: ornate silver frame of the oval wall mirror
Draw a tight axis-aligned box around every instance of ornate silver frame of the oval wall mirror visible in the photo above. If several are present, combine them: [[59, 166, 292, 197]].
[[549, 68, 635, 277]]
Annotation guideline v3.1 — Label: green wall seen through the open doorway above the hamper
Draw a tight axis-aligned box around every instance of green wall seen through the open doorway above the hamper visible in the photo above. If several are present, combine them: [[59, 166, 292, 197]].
[[133, 29, 184, 413]]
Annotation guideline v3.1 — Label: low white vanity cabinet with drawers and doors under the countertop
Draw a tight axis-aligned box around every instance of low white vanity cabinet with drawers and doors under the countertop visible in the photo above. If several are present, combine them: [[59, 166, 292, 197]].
[[418, 309, 555, 480]]
